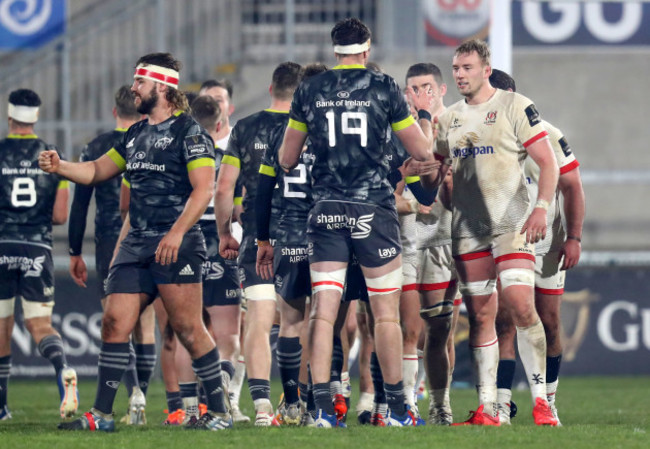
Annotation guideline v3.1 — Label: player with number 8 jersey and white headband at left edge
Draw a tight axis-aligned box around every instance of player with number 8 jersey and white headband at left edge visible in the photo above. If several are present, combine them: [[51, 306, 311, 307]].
[[0, 89, 79, 420]]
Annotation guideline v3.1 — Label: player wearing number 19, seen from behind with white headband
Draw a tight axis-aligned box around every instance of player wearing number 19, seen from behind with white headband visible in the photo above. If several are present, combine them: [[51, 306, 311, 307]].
[[279, 19, 433, 427]]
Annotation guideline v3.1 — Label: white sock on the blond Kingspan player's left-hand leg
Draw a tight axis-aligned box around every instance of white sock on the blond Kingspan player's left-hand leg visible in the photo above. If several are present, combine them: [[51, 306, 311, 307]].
[[472, 338, 499, 416]]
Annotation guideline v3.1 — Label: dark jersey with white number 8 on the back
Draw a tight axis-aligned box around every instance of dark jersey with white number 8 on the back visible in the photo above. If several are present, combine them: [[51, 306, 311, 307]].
[[0, 134, 68, 248]]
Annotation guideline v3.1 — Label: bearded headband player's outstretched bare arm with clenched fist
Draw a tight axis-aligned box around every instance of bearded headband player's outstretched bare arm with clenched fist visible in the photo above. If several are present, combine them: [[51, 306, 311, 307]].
[[38, 150, 122, 185]]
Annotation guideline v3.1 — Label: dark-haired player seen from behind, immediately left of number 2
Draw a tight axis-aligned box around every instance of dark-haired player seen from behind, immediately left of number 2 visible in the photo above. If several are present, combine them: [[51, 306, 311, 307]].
[[214, 62, 301, 427]]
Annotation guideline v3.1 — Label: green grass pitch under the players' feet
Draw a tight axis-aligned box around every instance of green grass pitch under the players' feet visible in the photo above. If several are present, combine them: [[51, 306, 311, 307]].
[[0, 377, 650, 449]]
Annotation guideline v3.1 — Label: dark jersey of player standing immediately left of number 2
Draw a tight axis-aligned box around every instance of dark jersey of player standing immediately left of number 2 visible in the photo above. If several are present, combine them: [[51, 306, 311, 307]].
[[221, 109, 289, 237]]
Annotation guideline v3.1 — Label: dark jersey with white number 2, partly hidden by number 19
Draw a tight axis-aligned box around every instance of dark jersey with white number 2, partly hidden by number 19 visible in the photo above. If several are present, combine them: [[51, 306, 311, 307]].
[[260, 129, 314, 245]]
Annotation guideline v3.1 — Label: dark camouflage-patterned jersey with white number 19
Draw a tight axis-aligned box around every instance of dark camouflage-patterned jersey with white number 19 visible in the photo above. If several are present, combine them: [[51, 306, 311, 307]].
[[289, 65, 415, 204]]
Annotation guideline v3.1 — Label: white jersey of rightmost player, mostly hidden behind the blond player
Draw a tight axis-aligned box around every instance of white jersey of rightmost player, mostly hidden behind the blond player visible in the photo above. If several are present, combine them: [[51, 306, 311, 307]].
[[524, 120, 580, 256]]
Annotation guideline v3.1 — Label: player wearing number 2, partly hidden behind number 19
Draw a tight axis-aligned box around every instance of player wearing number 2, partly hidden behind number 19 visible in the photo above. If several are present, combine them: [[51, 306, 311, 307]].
[[255, 64, 327, 425]]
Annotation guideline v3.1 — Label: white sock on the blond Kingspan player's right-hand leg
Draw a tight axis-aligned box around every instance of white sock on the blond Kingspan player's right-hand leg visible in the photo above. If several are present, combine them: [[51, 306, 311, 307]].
[[517, 321, 546, 404]]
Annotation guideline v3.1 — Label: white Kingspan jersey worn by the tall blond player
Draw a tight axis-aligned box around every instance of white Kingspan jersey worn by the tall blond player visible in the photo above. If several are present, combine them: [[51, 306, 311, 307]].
[[436, 89, 548, 238]]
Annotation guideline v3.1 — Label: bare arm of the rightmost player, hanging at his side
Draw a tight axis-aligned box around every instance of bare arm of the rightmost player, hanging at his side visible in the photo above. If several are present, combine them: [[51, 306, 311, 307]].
[[558, 167, 585, 270]]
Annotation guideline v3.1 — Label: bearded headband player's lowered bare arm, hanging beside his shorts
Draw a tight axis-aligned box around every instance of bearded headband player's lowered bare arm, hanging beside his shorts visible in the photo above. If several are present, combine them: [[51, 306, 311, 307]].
[[156, 167, 215, 265]]
